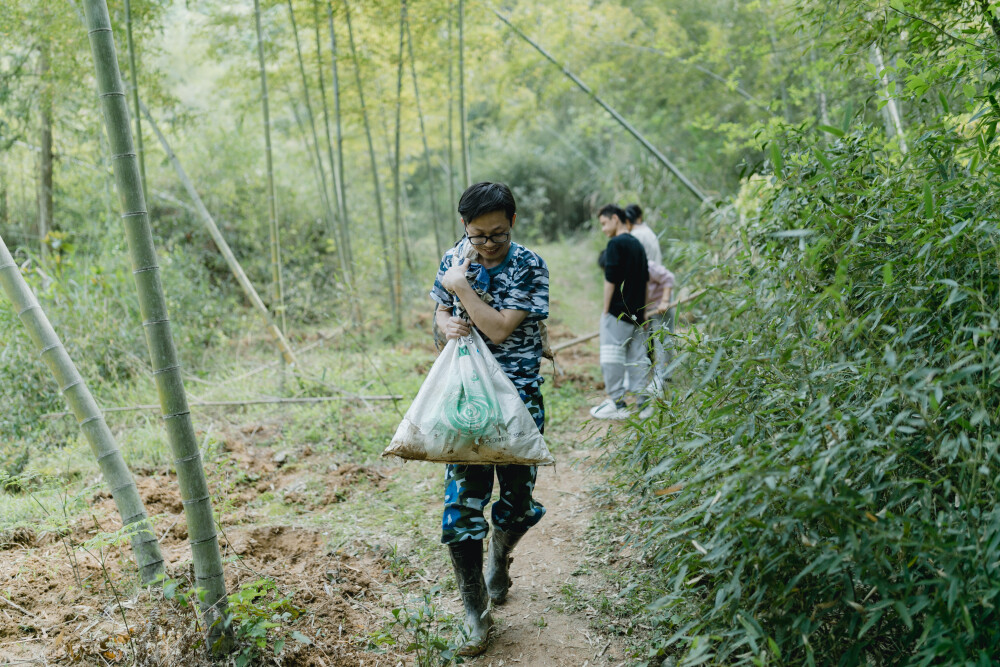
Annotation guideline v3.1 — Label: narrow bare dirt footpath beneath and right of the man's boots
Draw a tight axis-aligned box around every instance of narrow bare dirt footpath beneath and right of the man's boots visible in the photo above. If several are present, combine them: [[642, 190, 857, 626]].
[[454, 440, 624, 667]]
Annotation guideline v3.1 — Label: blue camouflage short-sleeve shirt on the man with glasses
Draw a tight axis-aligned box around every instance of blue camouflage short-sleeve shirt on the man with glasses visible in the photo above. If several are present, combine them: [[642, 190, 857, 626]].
[[431, 243, 549, 396]]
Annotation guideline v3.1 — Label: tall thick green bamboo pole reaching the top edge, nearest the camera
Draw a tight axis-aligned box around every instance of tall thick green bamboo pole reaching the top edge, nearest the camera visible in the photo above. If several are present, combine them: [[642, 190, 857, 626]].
[[84, 0, 232, 651]]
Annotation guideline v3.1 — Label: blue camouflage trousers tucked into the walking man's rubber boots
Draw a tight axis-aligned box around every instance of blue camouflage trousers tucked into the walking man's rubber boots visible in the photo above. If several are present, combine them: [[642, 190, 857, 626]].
[[441, 394, 545, 544]]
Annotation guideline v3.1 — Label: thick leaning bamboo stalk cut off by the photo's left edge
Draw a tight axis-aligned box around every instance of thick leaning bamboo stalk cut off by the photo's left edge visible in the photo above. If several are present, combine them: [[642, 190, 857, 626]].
[[0, 237, 163, 584]]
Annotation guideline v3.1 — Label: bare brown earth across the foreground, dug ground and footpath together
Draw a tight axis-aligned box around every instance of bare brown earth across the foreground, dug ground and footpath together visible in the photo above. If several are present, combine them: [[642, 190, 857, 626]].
[[0, 341, 628, 667]]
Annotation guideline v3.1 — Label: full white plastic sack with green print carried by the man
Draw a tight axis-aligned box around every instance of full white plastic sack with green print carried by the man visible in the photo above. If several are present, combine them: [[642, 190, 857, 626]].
[[382, 329, 555, 465]]
